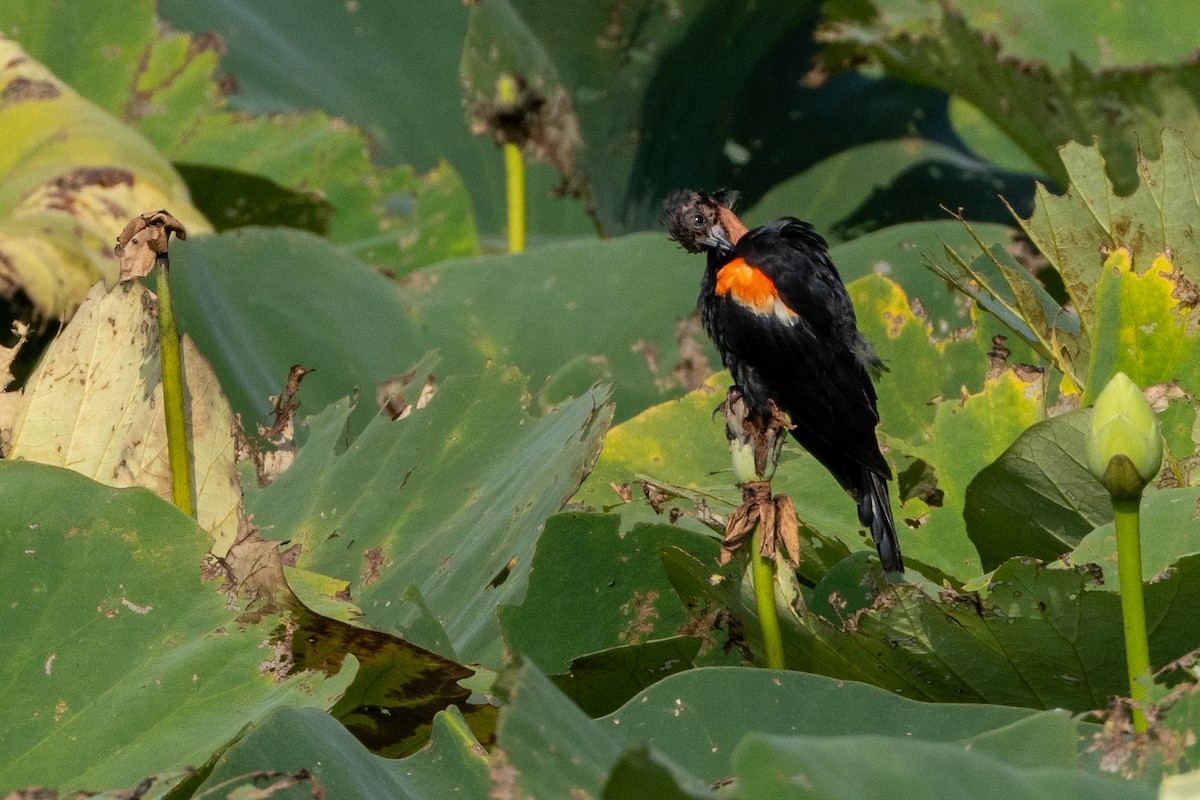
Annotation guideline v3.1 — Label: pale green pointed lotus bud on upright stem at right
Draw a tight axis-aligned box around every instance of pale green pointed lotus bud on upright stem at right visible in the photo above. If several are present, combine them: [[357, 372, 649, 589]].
[[1087, 372, 1163, 499]]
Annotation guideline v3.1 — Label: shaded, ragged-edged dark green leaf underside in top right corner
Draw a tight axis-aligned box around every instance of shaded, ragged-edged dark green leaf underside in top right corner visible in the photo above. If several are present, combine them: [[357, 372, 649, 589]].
[[822, 0, 1200, 192]]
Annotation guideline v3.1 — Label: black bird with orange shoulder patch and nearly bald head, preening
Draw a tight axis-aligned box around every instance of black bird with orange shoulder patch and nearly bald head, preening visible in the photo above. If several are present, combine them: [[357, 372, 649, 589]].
[[665, 192, 904, 572]]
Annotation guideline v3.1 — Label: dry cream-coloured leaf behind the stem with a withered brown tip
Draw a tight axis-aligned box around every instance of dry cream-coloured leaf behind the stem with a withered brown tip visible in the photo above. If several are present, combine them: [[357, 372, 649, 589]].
[[5, 283, 241, 555]]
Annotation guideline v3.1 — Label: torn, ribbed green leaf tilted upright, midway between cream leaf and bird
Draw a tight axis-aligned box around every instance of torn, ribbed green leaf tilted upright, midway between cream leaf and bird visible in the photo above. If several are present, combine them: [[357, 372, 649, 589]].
[[247, 362, 611, 664]]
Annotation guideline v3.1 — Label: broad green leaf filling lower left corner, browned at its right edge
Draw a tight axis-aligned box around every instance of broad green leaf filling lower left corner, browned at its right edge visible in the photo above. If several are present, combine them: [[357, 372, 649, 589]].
[[0, 461, 354, 792]]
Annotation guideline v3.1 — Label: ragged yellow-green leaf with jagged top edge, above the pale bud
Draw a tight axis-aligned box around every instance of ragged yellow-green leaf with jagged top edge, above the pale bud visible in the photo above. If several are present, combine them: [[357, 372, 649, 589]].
[[940, 128, 1200, 405]]
